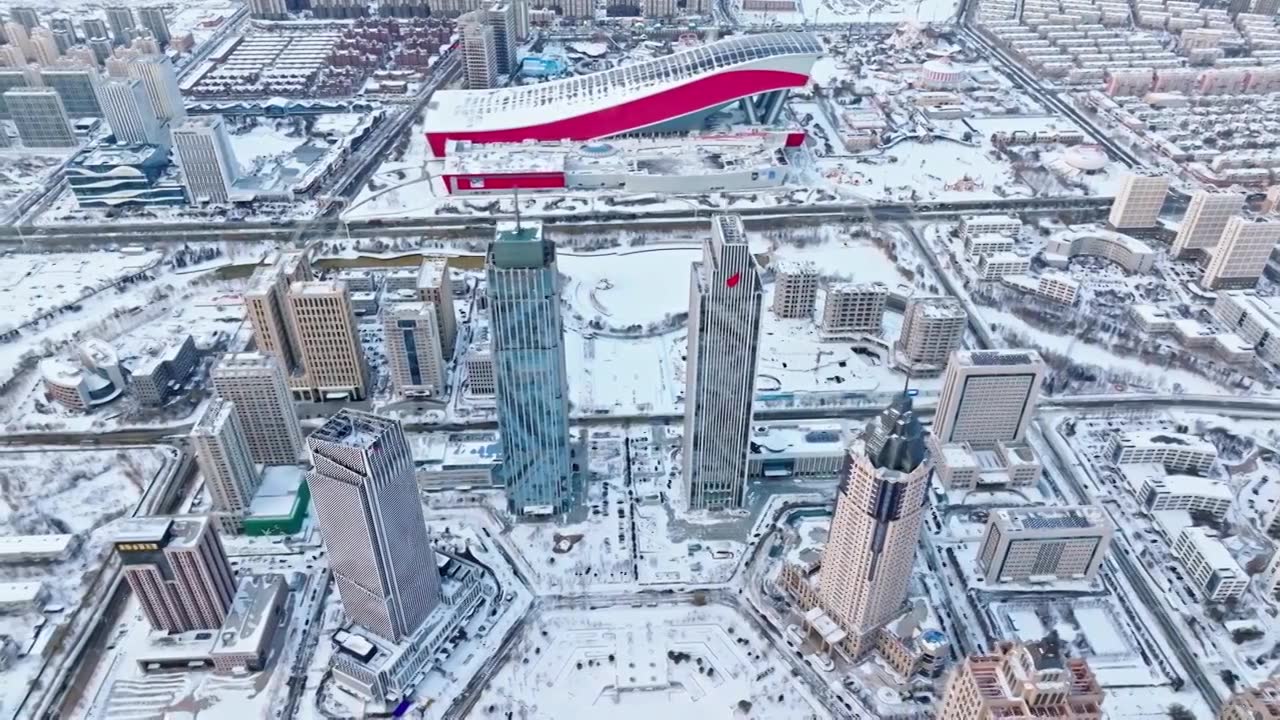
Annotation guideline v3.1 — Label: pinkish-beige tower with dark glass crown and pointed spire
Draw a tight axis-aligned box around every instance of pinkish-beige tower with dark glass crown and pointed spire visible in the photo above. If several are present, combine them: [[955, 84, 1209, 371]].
[[818, 392, 929, 655]]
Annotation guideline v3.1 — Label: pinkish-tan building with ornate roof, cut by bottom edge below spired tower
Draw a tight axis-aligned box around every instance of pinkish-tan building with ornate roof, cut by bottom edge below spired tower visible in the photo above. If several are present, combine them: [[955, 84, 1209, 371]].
[[934, 634, 1105, 720]]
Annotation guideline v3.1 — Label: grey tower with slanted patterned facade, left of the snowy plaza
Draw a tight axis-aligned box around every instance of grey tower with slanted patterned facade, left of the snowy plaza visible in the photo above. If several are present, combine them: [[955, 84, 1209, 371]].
[[307, 410, 440, 642]]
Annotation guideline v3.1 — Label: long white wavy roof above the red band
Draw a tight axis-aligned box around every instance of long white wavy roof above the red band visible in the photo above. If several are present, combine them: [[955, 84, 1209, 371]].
[[426, 32, 823, 132]]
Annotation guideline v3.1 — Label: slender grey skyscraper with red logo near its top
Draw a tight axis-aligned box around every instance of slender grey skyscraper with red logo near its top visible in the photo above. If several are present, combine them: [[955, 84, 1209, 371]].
[[684, 215, 764, 510]]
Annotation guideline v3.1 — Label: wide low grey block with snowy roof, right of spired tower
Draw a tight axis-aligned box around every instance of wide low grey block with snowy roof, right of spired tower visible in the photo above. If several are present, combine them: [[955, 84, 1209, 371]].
[[978, 505, 1112, 583]]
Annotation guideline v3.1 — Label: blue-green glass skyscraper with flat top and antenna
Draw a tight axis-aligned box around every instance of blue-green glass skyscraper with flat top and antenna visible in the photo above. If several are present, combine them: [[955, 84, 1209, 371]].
[[485, 223, 580, 516]]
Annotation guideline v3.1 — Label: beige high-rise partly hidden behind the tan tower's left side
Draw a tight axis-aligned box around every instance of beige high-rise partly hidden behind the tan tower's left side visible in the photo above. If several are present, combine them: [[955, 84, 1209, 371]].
[[241, 252, 312, 375]]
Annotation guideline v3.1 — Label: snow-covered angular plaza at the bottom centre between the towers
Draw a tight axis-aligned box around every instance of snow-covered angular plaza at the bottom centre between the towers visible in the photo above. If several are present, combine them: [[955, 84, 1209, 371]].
[[467, 602, 829, 720]]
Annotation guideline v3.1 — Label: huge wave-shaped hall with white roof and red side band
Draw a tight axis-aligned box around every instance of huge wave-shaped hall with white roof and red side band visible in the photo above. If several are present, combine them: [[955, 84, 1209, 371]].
[[425, 32, 822, 158]]
